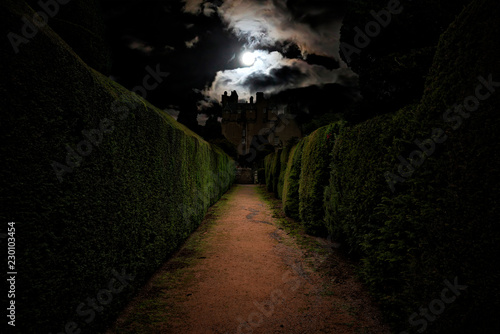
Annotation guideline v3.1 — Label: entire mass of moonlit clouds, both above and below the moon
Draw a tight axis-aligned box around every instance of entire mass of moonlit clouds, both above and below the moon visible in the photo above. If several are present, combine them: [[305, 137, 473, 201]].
[[183, 0, 356, 104]]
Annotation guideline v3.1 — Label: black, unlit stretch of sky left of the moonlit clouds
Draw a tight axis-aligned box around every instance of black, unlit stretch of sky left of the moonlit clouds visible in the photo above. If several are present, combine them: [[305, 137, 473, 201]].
[[102, 0, 244, 108]]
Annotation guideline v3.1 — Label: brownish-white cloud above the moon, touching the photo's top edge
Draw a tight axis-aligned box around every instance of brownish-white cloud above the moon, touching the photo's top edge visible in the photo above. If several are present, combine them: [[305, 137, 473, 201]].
[[218, 0, 345, 59]]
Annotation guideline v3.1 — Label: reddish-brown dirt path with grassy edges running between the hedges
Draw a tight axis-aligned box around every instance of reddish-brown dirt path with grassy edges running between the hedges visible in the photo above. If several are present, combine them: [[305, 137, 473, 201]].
[[108, 185, 388, 333]]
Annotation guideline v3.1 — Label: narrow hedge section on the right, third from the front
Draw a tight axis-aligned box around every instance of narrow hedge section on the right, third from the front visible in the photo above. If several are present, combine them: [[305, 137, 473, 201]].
[[282, 140, 305, 220]]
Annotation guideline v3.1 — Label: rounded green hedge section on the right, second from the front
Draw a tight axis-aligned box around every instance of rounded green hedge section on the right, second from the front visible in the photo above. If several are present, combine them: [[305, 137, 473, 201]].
[[299, 123, 342, 234]]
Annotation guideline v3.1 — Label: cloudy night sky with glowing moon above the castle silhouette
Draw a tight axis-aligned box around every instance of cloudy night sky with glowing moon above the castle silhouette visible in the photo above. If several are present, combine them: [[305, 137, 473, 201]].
[[98, 0, 356, 121]]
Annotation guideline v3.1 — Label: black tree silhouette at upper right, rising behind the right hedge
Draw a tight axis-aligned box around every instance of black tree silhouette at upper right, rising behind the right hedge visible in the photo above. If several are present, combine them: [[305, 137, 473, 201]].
[[340, 0, 471, 122]]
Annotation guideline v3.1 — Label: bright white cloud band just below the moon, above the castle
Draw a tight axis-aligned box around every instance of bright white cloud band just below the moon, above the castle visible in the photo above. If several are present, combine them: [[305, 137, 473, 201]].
[[203, 50, 356, 101]]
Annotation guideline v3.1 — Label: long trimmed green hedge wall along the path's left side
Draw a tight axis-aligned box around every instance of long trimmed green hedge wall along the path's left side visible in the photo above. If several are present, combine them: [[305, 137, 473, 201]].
[[0, 0, 235, 333]]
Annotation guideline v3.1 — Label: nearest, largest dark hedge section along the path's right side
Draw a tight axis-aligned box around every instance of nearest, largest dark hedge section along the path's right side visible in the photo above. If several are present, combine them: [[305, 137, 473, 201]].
[[325, 0, 500, 333]]
